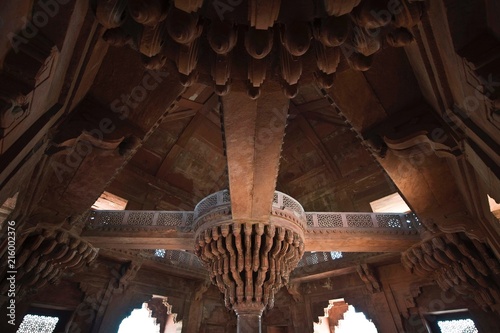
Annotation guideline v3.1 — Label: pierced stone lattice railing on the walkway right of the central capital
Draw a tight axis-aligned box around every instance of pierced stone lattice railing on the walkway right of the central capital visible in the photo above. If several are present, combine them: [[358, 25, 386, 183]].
[[305, 212, 420, 231]]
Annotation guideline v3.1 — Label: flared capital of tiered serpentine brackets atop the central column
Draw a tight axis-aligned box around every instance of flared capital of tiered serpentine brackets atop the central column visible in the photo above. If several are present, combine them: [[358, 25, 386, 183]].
[[194, 192, 305, 314]]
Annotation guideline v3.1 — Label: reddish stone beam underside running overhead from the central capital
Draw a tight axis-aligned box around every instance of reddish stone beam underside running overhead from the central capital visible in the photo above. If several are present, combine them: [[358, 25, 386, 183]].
[[222, 90, 289, 221]]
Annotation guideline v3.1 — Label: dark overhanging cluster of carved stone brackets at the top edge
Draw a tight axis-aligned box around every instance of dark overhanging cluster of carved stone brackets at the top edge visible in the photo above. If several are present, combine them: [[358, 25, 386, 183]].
[[91, 0, 424, 98]]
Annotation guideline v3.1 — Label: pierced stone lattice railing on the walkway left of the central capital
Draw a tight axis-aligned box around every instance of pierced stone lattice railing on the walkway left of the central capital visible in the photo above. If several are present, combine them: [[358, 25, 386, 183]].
[[87, 210, 193, 229]]
